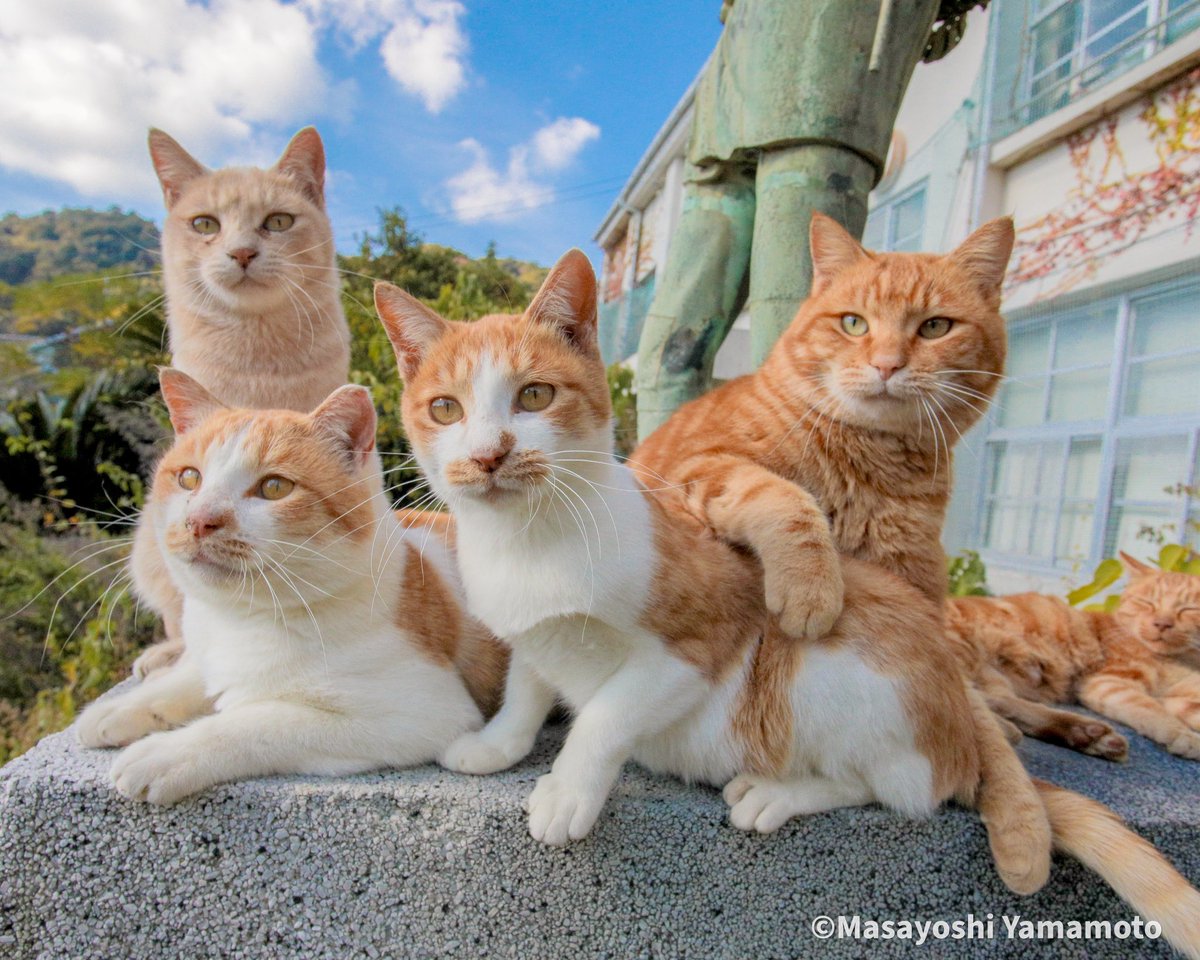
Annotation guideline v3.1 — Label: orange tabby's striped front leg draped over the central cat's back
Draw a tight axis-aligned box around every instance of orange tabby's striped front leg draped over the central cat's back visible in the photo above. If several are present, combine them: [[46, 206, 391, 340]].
[[679, 456, 845, 640]]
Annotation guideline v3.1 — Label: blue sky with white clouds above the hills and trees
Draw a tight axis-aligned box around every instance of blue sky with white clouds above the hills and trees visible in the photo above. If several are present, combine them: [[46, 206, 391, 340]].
[[0, 0, 720, 263]]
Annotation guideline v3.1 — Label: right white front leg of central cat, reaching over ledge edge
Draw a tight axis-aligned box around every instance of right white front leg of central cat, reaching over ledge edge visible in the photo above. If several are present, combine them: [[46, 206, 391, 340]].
[[526, 637, 710, 846]]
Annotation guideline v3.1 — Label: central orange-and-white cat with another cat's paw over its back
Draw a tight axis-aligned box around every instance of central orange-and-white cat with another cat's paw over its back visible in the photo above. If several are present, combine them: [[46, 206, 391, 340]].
[[376, 251, 1200, 956]]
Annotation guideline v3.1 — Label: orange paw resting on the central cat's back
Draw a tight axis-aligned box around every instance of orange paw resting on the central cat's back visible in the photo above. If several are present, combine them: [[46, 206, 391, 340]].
[[763, 550, 845, 640]]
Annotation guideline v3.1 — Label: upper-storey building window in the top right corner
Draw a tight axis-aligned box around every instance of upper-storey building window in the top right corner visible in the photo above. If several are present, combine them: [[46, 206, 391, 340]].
[[1014, 0, 1200, 122]]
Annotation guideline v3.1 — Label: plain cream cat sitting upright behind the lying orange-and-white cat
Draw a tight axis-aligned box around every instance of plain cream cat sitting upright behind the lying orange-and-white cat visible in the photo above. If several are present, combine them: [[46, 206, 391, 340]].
[[133, 127, 350, 676]]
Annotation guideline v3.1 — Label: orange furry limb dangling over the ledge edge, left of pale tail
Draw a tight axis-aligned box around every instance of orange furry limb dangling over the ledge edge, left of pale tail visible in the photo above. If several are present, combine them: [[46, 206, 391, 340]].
[[967, 684, 1054, 894]]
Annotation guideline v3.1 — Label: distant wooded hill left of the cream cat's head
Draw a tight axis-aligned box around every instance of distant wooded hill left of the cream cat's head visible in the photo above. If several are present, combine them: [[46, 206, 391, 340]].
[[0, 206, 158, 286]]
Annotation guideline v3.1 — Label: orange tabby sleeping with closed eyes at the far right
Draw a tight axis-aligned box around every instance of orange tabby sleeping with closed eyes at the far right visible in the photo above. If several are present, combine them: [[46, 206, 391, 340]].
[[946, 553, 1200, 760]]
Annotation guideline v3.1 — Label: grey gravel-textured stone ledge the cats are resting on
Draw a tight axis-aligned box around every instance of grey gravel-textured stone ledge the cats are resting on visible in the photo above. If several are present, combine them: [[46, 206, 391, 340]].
[[0, 696, 1200, 960]]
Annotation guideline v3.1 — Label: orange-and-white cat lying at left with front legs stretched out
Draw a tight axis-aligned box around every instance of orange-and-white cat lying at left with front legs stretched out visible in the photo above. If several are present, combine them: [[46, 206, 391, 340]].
[[77, 370, 503, 804]]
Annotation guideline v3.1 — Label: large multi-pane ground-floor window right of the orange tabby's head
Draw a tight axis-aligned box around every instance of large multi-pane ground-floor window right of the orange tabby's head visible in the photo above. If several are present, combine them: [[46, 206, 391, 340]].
[[979, 272, 1200, 568]]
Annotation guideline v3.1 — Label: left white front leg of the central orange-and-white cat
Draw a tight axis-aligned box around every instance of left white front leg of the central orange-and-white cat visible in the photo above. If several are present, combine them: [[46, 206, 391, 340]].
[[438, 652, 554, 774]]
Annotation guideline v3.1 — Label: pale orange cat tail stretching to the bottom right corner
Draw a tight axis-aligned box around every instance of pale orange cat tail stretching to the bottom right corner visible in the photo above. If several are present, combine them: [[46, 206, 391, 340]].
[[1033, 780, 1200, 960]]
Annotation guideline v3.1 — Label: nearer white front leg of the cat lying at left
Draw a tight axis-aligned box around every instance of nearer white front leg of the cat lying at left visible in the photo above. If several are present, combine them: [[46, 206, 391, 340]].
[[112, 700, 403, 804]]
